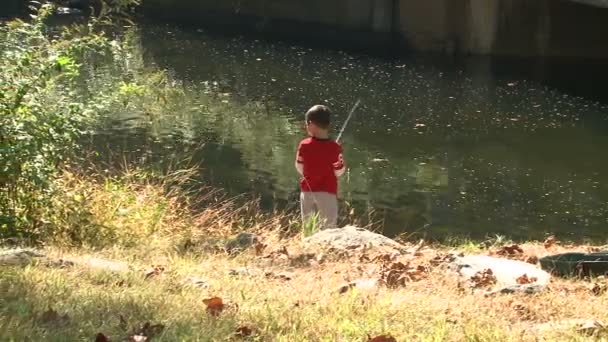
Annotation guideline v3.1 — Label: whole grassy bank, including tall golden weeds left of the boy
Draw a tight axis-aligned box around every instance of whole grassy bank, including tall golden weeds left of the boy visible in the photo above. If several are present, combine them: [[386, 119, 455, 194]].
[[0, 170, 608, 341]]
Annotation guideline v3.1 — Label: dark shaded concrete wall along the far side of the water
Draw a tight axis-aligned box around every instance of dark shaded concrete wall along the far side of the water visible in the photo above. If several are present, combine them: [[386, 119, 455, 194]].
[[51, 0, 608, 58]]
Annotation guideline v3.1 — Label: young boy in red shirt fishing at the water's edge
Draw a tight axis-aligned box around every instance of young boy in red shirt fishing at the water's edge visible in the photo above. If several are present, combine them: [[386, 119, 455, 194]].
[[295, 105, 346, 229]]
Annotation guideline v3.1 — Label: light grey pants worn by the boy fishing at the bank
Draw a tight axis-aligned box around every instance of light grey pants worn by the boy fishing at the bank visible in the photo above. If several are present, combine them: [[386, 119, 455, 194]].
[[300, 192, 338, 229]]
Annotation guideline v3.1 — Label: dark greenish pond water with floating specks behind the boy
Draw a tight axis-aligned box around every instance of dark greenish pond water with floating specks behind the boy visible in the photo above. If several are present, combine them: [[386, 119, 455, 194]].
[[92, 26, 608, 239]]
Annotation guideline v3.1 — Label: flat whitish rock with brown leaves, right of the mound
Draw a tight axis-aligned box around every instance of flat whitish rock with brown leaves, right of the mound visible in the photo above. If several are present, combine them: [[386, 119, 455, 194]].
[[450, 255, 551, 294]]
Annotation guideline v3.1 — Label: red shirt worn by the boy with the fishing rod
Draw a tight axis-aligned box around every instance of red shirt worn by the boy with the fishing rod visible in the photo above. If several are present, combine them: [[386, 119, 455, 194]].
[[296, 137, 345, 194]]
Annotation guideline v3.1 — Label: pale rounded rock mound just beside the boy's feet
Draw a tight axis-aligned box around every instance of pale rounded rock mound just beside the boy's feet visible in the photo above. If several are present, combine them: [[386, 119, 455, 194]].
[[304, 226, 405, 251]]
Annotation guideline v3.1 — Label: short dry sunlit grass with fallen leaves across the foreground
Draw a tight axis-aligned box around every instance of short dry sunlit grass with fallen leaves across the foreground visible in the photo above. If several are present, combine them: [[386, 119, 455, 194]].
[[0, 234, 608, 341]]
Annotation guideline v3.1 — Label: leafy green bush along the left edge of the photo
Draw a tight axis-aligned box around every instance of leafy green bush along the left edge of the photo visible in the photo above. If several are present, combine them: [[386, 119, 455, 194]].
[[0, 0, 135, 236]]
